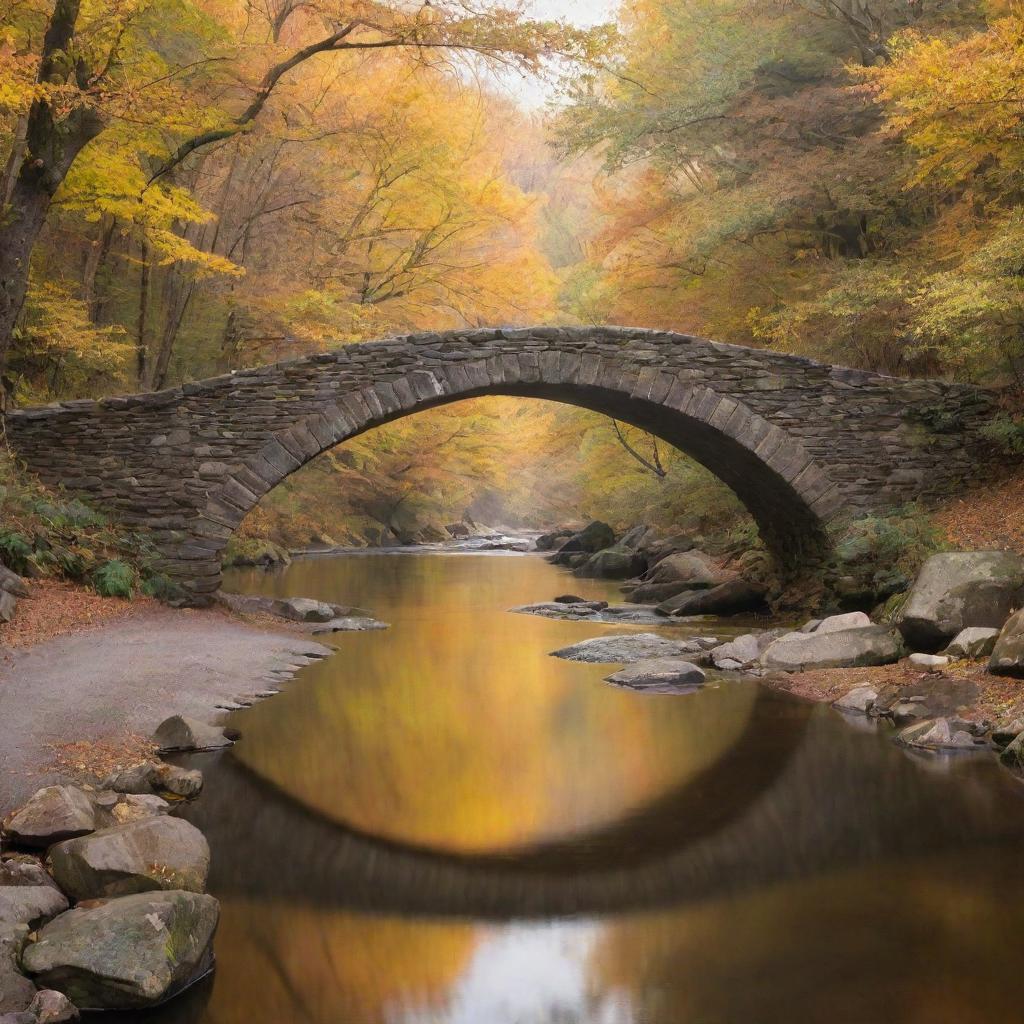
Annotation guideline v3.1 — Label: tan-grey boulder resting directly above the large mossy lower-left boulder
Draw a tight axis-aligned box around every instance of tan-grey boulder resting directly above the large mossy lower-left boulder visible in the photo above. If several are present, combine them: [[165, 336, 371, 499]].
[[49, 815, 210, 900]]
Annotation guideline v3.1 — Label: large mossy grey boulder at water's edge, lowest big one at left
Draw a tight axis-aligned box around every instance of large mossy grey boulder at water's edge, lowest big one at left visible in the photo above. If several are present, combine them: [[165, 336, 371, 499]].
[[22, 891, 219, 1010]]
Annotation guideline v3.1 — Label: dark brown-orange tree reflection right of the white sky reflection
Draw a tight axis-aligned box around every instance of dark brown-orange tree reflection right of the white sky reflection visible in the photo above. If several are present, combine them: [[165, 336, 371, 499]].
[[589, 850, 1024, 1024]]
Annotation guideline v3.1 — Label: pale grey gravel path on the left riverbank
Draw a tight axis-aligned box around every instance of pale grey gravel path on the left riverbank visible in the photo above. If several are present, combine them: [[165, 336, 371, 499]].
[[0, 608, 331, 816]]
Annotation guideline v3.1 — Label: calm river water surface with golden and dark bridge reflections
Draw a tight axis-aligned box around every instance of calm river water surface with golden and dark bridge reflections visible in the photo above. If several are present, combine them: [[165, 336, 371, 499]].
[[140, 554, 1024, 1024]]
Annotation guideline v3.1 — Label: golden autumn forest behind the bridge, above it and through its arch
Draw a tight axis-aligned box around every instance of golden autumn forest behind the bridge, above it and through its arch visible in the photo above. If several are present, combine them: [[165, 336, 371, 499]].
[[0, 0, 1024, 547]]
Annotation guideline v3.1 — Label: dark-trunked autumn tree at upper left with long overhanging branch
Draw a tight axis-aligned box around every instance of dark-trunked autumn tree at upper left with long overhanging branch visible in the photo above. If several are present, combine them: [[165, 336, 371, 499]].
[[0, 0, 604, 407]]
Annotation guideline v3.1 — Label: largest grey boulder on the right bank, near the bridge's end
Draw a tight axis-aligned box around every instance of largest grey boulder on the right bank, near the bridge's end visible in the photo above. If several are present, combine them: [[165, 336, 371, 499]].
[[899, 551, 1024, 651]]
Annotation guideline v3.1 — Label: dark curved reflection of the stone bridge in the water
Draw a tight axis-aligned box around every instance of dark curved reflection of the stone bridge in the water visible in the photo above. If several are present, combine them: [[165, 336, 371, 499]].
[[189, 691, 1024, 920]]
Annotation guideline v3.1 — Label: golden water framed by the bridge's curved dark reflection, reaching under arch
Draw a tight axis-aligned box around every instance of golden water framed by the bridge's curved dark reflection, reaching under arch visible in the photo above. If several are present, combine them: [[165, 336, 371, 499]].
[[224, 555, 756, 854]]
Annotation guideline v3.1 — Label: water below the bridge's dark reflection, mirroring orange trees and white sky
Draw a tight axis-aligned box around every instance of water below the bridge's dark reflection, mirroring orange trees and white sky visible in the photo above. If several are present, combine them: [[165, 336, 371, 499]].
[[192, 853, 1024, 1024]]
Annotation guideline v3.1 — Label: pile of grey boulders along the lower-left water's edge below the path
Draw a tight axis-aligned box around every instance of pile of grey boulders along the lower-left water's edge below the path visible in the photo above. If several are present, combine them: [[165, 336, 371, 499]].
[[0, 774, 219, 1024]]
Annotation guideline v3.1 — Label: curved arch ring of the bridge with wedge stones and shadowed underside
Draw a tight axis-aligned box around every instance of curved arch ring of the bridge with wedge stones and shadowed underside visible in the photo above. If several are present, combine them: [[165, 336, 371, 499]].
[[188, 351, 841, 599]]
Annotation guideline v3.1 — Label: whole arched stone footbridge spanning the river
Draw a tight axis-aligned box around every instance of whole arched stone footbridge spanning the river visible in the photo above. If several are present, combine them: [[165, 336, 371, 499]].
[[0, 328, 993, 603]]
